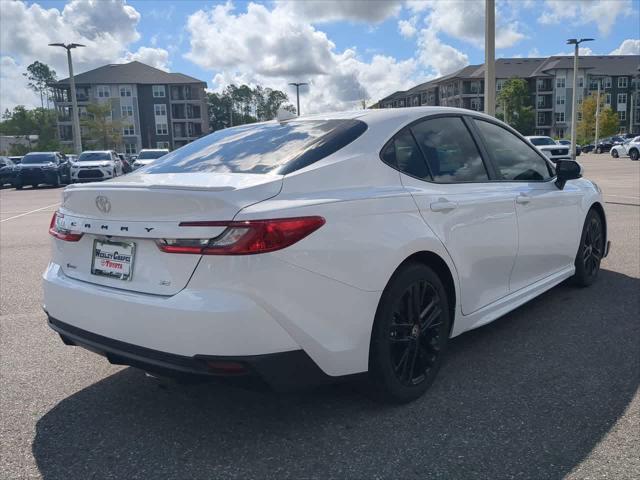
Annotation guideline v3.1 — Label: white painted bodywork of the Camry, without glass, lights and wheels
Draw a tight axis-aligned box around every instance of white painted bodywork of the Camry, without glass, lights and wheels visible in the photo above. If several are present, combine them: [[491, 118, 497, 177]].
[[44, 107, 604, 386]]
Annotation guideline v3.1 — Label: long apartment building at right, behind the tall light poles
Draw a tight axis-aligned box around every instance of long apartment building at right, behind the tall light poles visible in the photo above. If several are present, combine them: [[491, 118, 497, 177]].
[[376, 55, 640, 137]]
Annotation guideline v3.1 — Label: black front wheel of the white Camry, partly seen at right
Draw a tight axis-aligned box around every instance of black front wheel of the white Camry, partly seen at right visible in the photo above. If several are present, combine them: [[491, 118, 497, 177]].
[[573, 209, 605, 287]]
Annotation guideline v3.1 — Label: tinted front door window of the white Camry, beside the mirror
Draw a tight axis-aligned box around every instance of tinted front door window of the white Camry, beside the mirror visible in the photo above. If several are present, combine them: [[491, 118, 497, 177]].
[[475, 119, 551, 181]]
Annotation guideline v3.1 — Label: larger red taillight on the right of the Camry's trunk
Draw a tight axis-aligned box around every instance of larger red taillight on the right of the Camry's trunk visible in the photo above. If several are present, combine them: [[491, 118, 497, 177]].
[[156, 217, 325, 255]]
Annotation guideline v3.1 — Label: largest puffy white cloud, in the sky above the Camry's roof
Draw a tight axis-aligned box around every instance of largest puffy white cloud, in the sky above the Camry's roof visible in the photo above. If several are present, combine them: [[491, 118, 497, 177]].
[[186, 3, 417, 112]]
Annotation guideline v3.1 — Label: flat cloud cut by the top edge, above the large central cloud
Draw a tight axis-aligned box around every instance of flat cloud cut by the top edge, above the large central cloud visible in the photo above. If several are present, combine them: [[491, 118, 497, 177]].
[[277, 0, 402, 23]]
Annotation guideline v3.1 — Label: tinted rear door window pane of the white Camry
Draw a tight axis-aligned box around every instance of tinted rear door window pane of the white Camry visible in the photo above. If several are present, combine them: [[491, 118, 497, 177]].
[[411, 117, 489, 183]]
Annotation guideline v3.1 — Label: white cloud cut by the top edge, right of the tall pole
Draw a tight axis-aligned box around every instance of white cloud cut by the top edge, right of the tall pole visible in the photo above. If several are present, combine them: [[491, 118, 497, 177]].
[[538, 0, 632, 35]]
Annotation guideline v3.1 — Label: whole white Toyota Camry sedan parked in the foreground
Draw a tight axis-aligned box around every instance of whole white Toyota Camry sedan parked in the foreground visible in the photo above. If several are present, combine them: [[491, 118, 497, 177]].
[[44, 107, 609, 402]]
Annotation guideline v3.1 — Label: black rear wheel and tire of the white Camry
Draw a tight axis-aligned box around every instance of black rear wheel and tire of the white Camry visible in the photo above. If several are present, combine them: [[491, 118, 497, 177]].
[[369, 263, 451, 403]]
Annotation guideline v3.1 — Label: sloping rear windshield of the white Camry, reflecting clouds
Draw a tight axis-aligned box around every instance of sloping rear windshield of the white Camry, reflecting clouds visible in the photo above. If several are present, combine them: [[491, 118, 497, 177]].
[[146, 119, 367, 175]]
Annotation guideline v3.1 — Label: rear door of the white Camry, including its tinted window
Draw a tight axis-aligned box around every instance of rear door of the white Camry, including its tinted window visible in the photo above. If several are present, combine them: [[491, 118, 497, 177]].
[[382, 116, 517, 314]]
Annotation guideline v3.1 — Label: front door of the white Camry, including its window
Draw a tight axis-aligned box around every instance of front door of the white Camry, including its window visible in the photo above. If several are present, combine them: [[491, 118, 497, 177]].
[[474, 119, 583, 291]]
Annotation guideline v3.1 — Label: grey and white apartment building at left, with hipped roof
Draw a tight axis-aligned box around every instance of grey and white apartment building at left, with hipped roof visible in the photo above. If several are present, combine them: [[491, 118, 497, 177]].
[[52, 62, 209, 153]]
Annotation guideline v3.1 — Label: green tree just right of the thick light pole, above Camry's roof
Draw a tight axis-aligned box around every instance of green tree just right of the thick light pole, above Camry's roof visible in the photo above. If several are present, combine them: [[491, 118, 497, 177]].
[[497, 78, 535, 135]]
